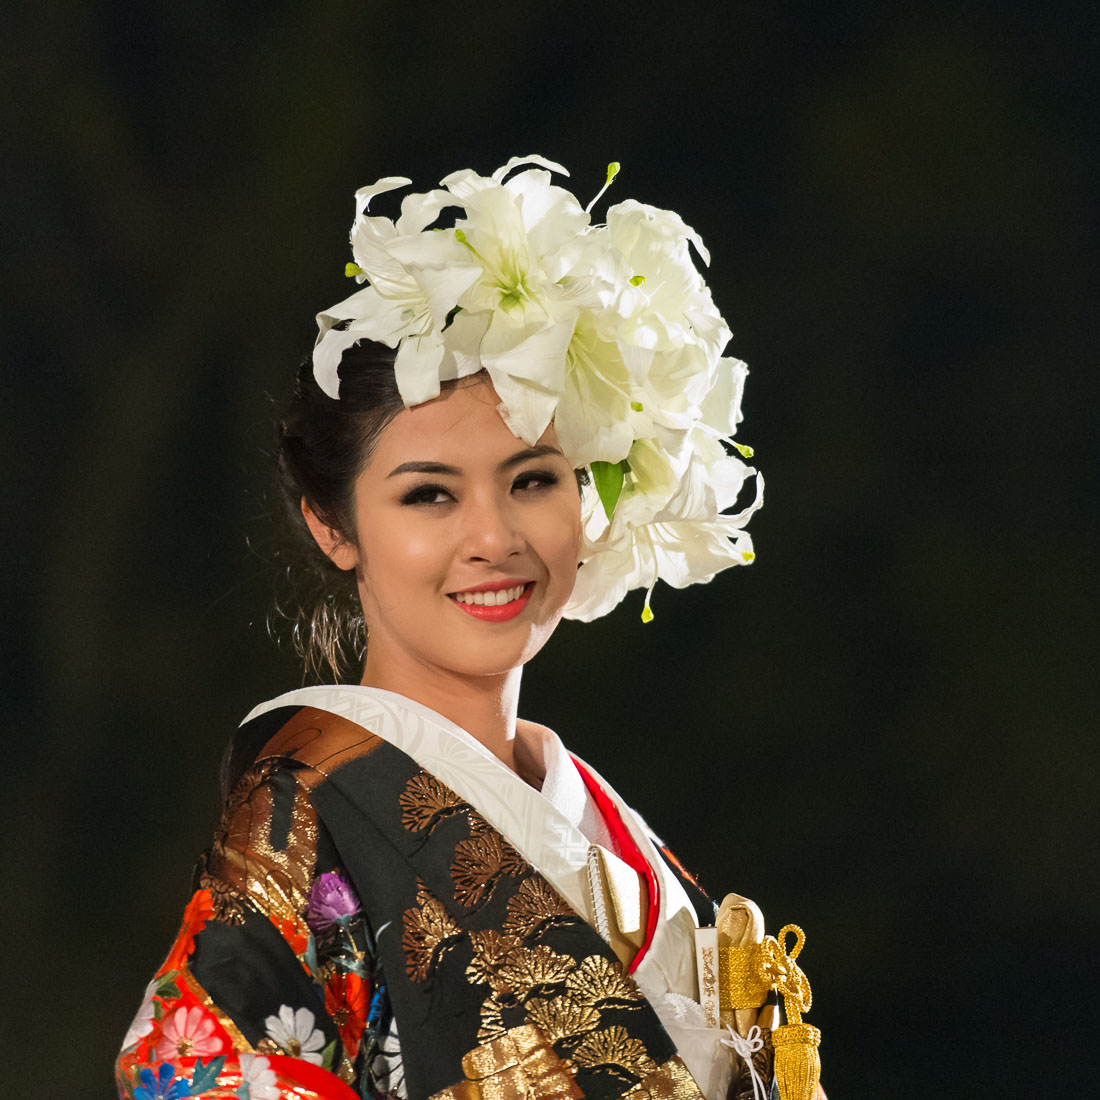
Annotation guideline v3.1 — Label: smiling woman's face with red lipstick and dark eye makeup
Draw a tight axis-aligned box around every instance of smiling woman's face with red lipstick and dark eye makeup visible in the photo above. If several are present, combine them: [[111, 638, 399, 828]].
[[337, 381, 581, 685]]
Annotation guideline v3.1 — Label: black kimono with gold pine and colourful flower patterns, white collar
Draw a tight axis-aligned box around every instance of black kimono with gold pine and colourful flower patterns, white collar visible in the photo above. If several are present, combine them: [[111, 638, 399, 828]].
[[116, 686, 774, 1100]]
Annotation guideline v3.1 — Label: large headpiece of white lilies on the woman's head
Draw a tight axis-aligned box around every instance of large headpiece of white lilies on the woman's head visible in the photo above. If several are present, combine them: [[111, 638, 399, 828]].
[[314, 155, 763, 622]]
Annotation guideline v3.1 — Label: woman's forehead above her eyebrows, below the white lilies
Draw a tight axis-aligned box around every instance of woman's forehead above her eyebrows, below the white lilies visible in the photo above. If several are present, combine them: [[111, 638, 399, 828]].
[[366, 381, 558, 476]]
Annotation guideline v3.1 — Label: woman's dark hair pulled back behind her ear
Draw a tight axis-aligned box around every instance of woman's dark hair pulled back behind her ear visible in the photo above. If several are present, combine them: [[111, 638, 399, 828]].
[[277, 340, 404, 680]]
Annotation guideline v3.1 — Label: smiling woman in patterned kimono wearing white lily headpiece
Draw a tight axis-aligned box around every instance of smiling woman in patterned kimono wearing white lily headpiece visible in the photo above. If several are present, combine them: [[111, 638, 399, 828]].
[[118, 157, 817, 1100]]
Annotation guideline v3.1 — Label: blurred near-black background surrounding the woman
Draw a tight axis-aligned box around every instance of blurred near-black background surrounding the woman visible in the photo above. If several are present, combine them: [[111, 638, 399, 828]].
[[0, 0, 1100, 1100]]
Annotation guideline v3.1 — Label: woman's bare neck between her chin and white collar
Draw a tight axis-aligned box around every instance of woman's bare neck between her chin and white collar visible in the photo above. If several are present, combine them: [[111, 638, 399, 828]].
[[361, 651, 524, 771]]
